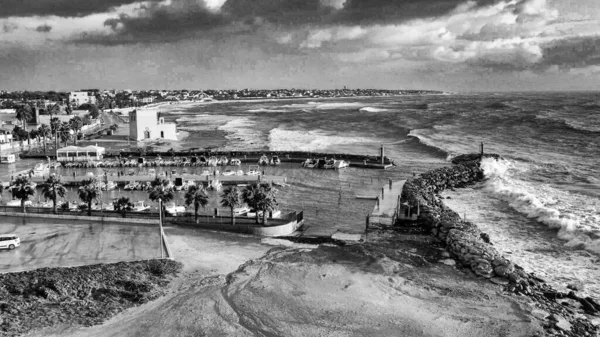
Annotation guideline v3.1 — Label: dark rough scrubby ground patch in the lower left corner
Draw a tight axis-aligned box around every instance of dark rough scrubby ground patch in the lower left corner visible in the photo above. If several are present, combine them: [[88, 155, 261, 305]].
[[0, 260, 181, 337]]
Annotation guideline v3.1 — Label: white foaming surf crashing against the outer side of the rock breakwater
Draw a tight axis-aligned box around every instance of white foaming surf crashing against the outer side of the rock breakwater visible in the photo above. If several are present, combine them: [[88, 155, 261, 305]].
[[481, 158, 600, 253]]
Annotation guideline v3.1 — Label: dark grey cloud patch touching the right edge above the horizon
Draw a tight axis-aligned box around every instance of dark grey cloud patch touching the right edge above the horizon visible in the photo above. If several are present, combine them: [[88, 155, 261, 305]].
[[541, 36, 600, 68]]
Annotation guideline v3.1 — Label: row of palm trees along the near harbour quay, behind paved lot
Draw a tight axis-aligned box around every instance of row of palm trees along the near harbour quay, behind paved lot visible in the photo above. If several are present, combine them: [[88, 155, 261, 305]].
[[0, 174, 278, 225]]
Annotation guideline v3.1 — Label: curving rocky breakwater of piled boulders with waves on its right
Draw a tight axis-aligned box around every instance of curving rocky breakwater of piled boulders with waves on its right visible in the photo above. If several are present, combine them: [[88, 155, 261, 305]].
[[402, 155, 600, 336]]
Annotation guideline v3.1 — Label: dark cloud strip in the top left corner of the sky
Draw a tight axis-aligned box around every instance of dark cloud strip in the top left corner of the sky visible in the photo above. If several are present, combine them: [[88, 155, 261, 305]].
[[0, 0, 162, 17]]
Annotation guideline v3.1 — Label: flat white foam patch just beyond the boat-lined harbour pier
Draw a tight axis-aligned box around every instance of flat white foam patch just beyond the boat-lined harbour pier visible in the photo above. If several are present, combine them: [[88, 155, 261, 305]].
[[269, 128, 379, 151]]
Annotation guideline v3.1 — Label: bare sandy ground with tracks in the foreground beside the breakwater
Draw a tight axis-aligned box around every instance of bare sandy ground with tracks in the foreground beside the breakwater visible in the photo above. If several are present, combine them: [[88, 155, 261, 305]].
[[27, 228, 541, 336]]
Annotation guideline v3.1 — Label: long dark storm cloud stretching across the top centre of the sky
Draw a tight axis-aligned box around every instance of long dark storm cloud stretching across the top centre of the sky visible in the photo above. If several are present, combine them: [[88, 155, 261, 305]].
[[76, 0, 496, 44]]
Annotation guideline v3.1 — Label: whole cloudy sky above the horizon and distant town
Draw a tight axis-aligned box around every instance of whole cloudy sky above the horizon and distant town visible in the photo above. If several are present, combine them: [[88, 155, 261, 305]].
[[0, 0, 600, 92]]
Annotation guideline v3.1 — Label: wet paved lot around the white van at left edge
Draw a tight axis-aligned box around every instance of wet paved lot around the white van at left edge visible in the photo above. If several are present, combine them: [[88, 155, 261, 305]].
[[0, 217, 160, 272]]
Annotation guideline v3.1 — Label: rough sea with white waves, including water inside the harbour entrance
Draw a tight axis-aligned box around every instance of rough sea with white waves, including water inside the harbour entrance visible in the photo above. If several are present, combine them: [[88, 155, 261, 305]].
[[167, 93, 600, 295]]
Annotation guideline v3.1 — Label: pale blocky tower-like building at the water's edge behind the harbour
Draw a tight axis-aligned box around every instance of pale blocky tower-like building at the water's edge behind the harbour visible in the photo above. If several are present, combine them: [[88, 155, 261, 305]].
[[129, 109, 177, 140]]
